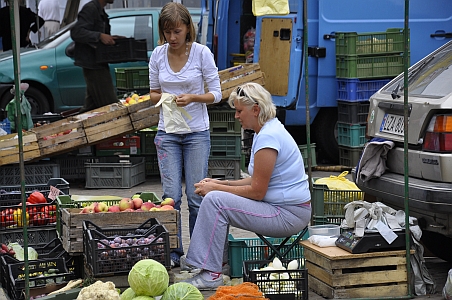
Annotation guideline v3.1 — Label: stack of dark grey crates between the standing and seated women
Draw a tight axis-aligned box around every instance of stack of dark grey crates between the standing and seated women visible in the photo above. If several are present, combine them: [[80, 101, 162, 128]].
[[208, 106, 242, 179]]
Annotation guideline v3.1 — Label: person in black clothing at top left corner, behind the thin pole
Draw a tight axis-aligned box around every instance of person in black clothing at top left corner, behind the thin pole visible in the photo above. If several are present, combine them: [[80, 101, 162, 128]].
[[0, 0, 44, 51]]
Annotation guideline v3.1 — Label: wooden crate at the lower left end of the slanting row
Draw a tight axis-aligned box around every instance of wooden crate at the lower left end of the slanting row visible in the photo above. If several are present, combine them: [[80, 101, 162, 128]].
[[0, 132, 41, 165]]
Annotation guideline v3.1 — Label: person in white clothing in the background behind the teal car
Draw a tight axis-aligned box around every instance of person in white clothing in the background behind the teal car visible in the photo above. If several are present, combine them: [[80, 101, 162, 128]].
[[38, 0, 60, 41]]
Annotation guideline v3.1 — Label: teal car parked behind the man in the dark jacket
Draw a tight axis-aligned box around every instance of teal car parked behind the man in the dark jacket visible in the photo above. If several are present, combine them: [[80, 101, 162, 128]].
[[0, 8, 200, 115]]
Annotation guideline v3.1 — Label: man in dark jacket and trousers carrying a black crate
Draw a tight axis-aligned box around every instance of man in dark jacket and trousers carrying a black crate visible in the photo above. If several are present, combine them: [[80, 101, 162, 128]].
[[71, 0, 118, 112]]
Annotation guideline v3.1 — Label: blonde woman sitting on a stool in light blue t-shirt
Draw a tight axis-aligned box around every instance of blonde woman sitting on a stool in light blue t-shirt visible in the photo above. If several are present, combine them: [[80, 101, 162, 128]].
[[181, 83, 311, 290]]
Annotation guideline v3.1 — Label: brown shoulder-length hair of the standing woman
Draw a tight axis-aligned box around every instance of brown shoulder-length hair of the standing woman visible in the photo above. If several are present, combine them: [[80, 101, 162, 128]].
[[158, 2, 196, 45]]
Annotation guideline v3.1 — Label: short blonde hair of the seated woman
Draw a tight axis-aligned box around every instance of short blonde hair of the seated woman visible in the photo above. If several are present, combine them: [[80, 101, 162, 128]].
[[228, 82, 276, 126]]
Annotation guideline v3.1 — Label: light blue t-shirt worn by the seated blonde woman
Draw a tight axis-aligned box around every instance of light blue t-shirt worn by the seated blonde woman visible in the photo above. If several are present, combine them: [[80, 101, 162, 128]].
[[248, 118, 311, 205]]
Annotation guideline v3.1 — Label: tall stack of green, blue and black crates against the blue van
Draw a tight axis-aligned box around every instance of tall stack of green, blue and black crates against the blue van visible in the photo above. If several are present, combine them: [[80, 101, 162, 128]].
[[336, 28, 404, 167]]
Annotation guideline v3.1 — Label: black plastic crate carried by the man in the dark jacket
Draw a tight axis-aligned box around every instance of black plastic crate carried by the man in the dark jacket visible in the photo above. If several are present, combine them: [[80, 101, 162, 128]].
[[96, 38, 148, 63]]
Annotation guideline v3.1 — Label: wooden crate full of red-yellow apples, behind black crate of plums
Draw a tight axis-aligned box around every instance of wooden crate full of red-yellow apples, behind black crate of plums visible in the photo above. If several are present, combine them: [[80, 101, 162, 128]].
[[60, 208, 180, 254]]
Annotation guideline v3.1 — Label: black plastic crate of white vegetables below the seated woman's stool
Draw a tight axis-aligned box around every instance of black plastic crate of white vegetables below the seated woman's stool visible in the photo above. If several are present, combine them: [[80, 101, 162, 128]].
[[243, 260, 309, 300]]
